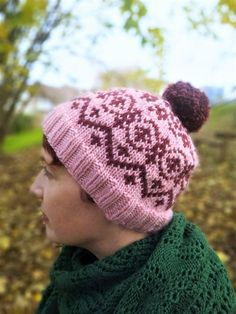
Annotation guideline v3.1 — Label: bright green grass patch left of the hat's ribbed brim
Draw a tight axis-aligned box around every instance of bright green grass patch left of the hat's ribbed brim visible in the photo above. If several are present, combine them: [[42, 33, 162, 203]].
[[3, 129, 42, 154]]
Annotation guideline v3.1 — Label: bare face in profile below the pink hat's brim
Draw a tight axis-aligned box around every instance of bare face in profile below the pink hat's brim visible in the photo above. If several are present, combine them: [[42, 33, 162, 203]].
[[30, 148, 108, 247]]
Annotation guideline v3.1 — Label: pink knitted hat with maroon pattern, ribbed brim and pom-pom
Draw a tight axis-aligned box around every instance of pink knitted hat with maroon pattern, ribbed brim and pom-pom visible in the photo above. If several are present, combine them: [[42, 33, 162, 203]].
[[43, 82, 209, 233]]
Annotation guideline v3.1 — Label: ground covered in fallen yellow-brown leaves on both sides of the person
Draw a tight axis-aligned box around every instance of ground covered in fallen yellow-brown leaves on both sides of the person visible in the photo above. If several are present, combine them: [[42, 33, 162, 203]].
[[0, 135, 236, 314]]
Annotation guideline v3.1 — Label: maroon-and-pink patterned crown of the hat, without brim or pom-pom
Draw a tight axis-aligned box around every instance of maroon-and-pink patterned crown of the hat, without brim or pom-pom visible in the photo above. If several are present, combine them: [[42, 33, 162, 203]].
[[71, 89, 196, 209]]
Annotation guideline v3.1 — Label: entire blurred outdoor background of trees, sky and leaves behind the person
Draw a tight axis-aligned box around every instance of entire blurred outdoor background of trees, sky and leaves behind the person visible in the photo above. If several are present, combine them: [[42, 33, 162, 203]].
[[0, 0, 236, 314]]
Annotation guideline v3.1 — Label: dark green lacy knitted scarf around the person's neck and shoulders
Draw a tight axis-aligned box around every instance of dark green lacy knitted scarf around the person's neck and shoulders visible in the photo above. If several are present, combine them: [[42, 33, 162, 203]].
[[37, 213, 236, 314]]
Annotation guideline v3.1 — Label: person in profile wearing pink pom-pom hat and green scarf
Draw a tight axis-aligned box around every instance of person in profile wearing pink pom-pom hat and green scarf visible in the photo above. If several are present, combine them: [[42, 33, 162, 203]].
[[31, 82, 236, 314]]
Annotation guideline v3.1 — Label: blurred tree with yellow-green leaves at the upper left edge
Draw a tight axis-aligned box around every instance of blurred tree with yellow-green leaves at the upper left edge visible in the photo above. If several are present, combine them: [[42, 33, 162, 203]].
[[0, 0, 70, 147]]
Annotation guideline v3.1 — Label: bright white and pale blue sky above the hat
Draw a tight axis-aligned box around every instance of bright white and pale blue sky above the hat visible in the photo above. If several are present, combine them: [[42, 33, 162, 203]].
[[32, 0, 236, 89]]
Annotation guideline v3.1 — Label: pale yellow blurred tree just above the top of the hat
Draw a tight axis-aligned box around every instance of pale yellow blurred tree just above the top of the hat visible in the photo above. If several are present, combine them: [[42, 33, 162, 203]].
[[99, 69, 166, 93]]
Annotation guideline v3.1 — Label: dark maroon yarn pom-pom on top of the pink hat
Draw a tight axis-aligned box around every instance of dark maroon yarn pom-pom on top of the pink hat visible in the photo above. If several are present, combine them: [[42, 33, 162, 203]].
[[162, 81, 210, 132]]
